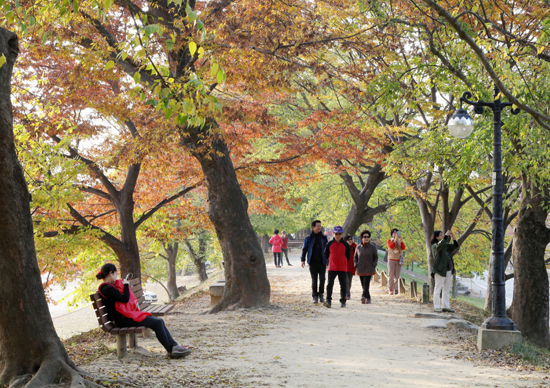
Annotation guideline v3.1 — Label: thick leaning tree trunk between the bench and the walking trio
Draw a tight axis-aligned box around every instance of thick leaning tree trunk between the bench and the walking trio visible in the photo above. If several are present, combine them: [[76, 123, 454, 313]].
[[181, 127, 271, 312]]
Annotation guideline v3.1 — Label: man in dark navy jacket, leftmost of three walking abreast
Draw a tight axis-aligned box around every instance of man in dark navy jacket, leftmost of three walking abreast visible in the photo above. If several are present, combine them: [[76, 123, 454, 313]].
[[300, 220, 328, 304]]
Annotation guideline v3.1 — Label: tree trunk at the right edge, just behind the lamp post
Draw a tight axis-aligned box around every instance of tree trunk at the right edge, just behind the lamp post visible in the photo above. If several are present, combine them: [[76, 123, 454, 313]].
[[509, 179, 550, 347]]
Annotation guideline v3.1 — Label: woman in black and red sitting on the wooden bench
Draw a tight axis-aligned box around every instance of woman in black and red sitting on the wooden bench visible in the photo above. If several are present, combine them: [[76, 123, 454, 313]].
[[96, 263, 191, 358]]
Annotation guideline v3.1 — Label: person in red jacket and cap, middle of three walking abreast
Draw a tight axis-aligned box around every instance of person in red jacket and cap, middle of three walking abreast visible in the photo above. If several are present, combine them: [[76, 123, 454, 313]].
[[324, 226, 350, 308]]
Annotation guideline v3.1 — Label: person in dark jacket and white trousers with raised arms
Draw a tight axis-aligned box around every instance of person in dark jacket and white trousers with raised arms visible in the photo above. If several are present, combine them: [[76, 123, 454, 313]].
[[431, 230, 459, 313]]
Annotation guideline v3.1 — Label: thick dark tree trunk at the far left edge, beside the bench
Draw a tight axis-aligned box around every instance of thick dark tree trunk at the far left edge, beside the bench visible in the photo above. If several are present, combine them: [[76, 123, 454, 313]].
[[0, 28, 90, 387]]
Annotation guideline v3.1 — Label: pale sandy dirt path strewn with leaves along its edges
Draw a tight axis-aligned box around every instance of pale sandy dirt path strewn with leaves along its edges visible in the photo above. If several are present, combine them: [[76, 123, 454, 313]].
[[83, 255, 550, 388]]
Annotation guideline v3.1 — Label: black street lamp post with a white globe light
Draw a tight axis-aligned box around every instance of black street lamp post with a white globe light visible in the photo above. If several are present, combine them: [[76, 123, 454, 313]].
[[448, 86, 520, 330]]
